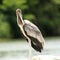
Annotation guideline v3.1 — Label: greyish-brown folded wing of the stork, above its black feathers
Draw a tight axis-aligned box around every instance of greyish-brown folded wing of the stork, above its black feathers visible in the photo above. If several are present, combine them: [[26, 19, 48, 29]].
[[24, 20, 44, 43]]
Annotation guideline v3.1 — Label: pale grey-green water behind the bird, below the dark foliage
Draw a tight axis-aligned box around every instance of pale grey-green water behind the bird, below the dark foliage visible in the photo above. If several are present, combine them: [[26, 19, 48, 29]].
[[0, 38, 60, 60]]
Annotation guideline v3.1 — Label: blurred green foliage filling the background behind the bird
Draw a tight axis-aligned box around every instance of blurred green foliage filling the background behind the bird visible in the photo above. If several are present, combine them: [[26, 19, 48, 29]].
[[0, 0, 60, 38]]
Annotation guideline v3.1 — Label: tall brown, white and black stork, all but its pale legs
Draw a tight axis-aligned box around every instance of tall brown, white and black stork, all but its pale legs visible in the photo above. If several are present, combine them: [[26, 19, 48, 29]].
[[16, 9, 45, 52]]
